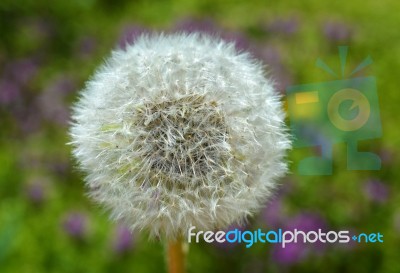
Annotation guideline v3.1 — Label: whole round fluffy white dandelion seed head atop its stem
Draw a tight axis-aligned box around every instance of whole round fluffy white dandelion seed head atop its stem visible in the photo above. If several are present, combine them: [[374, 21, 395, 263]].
[[70, 34, 290, 238]]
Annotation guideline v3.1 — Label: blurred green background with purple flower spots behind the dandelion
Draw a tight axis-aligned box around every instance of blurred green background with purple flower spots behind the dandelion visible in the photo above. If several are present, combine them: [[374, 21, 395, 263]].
[[0, 0, 400, 273]]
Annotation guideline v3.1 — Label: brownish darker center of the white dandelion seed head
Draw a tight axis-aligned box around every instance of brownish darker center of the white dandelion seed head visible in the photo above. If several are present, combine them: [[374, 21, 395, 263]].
[[136, 96, 229, 181]]
